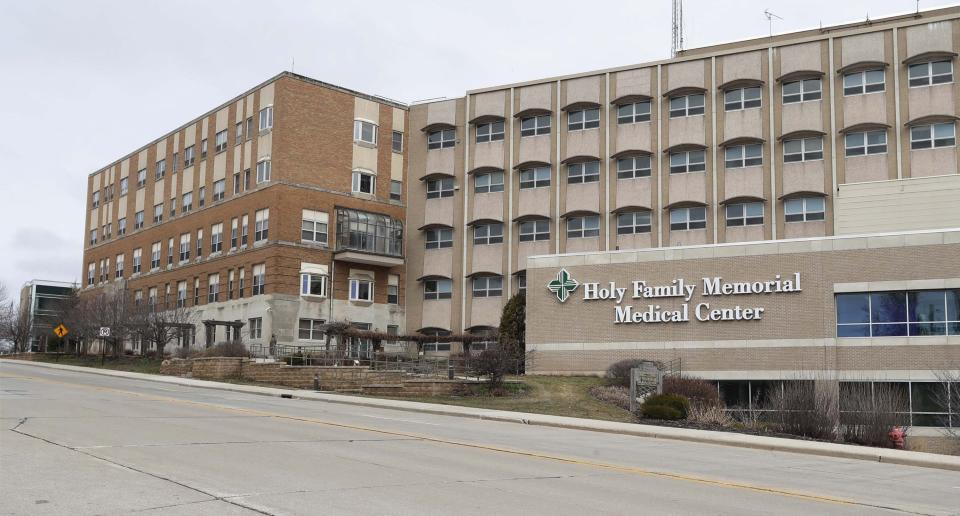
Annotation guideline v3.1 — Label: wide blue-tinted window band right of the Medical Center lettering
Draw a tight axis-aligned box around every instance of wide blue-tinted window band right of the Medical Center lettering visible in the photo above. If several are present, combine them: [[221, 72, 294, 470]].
[[835, 290, 960, 337]]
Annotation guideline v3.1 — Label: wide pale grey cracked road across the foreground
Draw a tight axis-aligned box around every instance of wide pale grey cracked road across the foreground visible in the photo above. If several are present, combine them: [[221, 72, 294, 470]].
[[0, 362, 960, 516]]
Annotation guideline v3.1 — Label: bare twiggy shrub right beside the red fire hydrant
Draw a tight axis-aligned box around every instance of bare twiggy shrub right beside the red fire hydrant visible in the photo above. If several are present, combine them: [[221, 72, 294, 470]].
[[840, 382, 909, 448]]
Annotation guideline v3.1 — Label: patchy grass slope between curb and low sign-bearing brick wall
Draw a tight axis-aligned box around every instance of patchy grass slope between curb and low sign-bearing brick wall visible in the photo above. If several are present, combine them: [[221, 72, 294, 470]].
[[376, 376, 636, 422]]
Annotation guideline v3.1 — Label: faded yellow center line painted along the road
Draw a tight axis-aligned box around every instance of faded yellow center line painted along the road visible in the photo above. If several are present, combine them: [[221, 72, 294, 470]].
[[0, 375, 858, 505]]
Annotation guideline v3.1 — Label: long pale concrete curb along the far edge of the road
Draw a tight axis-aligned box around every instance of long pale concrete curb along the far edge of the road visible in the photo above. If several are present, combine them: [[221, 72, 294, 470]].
[[7, 360, 960, 471]]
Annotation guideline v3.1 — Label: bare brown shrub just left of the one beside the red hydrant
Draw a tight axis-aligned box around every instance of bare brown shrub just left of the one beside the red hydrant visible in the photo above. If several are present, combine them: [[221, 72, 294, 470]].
[[763, 380, 837, 440]]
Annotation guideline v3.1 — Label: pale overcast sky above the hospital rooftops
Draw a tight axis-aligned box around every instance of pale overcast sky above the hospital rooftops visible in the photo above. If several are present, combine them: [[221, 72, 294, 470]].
[[0, 0, 949, 300]]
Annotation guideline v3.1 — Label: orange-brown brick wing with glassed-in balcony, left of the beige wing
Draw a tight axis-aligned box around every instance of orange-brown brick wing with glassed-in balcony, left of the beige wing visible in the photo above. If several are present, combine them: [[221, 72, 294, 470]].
[[83, 73, 407, 345]]
